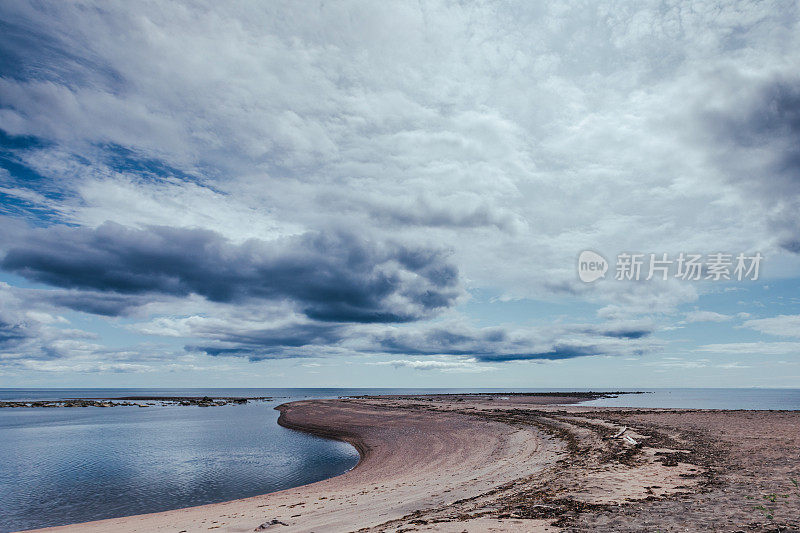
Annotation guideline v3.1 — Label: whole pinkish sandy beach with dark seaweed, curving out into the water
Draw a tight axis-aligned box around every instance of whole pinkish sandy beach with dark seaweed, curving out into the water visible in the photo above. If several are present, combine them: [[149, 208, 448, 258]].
[[26, 395, 800, 533]]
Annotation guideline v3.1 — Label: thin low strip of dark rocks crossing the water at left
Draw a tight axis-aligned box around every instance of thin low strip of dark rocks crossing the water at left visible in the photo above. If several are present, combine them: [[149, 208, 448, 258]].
[[0, 396, 273, 409]]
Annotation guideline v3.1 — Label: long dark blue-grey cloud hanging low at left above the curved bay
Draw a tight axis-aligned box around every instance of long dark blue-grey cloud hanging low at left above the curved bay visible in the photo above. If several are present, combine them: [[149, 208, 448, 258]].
[[0, 223, 461, 322]]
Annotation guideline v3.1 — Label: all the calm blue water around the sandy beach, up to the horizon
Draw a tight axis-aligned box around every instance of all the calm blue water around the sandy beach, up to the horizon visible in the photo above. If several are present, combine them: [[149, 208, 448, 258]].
[[0, 389, 800, 533]]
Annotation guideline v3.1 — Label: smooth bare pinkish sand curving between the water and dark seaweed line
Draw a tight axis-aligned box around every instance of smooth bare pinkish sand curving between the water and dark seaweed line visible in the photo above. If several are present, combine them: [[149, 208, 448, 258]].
[[28, 400, 553, 533]]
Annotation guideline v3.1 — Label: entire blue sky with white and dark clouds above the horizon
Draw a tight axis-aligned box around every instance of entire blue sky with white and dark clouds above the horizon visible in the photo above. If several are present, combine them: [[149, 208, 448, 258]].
[[0, 0, 800, 387]]
